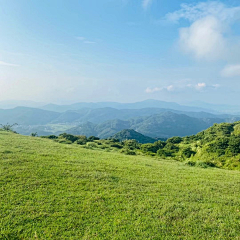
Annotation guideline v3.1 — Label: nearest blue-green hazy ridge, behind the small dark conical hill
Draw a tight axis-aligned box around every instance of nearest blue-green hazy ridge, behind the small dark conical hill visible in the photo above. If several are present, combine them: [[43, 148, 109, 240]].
[[67, 112, 229, 138]]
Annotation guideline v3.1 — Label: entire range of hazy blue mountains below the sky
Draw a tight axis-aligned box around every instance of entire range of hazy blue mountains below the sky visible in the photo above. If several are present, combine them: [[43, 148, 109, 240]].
[[0, 100, 240, 138]]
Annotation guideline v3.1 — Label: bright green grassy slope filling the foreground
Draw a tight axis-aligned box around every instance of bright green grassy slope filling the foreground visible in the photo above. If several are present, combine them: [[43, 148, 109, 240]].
[[0, 132, 240, 239]]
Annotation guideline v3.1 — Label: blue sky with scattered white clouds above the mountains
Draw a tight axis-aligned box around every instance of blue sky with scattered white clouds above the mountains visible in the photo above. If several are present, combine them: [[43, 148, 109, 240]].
[[0, 0, 240, 104]]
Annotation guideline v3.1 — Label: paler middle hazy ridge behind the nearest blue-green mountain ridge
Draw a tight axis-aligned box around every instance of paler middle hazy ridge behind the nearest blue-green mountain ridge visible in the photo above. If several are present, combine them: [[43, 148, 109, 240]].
[[0, 107, 238, 125]]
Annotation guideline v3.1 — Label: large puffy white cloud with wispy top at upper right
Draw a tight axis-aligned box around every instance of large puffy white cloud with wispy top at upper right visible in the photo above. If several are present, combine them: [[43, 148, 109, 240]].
[[166, 1, 240, 60]]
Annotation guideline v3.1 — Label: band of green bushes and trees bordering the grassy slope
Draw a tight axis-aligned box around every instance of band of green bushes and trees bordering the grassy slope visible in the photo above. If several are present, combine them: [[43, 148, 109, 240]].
[[41, 122, 240, 170]]
